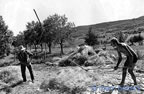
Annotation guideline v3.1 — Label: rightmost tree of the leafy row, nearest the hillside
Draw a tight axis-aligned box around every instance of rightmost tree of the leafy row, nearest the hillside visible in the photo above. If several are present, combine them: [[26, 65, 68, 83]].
[[55, 14, 75, 54]]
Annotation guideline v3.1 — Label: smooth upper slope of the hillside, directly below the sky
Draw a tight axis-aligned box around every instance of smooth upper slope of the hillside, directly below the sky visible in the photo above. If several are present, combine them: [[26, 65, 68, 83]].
[[74, 16, 144, 37]]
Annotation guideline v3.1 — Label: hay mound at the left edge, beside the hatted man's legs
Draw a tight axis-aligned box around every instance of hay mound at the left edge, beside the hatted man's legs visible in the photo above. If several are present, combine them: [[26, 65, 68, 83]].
[[0, 66, 21, 94]]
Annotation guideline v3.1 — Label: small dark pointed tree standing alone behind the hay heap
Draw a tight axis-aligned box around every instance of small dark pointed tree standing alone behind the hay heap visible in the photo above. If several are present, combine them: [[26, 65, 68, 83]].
[[85, 27, 98, 46]]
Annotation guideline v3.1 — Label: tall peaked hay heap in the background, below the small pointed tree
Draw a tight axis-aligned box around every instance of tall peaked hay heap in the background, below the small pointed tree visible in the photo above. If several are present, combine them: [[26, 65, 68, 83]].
[[58, 45, 116, 66]]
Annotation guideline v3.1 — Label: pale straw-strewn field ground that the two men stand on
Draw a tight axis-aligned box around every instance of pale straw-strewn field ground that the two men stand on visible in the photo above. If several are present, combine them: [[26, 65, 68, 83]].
[[0, 46, 144, 94]]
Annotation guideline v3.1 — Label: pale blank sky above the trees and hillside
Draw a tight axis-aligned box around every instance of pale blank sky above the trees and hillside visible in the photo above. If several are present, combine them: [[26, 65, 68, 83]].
[[0, 0, 144, 35]]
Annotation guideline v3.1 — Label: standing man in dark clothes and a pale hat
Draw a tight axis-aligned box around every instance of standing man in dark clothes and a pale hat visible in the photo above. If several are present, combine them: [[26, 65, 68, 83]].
[[17, 45, 34, 83]]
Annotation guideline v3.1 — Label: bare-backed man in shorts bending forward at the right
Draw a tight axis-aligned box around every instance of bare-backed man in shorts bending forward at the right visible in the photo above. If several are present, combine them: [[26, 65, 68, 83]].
[[111, 38, 138, 86]]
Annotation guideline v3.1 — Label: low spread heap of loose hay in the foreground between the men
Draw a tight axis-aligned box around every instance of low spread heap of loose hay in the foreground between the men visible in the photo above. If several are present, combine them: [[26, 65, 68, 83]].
[[40, 67, 101, 94]]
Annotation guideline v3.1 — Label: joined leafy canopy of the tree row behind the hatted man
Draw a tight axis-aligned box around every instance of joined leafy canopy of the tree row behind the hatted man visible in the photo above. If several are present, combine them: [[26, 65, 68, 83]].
[[13, 14, 76, 54]]
